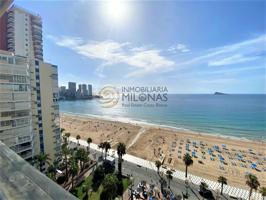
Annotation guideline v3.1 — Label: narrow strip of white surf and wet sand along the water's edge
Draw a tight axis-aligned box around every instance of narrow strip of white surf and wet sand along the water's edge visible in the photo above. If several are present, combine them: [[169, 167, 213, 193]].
[[60, 112, 266, 145]]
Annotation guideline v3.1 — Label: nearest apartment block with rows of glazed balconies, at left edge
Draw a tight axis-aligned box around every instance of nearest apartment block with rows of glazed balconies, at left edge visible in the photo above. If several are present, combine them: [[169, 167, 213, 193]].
[[0, 50, 34, 160]]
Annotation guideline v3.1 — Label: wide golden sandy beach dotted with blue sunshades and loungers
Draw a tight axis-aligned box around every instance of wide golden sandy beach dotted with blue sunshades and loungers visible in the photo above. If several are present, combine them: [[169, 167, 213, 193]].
[[60, 113, 266, 189]]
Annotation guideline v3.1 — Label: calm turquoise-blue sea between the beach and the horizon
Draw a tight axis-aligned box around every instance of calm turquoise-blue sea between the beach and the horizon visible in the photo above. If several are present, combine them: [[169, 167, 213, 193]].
[[59, 94, 266, 142]]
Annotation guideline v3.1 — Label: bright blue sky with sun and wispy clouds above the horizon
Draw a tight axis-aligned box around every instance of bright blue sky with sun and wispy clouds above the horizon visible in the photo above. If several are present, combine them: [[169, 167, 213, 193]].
[[15, 0, 266, 94]]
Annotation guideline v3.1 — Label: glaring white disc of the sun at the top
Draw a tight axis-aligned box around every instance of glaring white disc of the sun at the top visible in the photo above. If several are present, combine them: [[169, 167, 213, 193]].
[[103, 0, 130, 24]]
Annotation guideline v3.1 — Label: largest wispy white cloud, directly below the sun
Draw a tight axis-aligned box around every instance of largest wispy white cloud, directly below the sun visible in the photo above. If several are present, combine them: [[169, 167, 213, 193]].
[[49, 36, 175, 76]]
